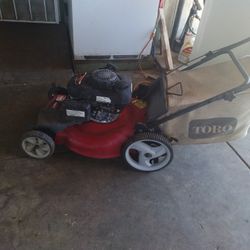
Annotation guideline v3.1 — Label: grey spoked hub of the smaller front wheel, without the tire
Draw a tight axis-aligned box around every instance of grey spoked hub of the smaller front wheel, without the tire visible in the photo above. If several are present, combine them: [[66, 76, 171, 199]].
[[22, 137, 50, 159]]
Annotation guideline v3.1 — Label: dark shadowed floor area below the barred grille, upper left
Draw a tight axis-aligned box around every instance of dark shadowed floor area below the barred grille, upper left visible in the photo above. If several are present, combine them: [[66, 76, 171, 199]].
[[0, 22, 72, 84]]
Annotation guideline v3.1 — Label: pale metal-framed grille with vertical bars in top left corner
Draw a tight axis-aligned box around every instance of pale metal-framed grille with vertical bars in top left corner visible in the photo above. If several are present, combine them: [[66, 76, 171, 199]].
[[0, 0, 59, 23]]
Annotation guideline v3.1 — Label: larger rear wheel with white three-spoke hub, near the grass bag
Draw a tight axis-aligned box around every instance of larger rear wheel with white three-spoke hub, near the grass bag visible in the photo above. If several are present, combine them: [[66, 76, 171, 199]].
[[122, 133, 173, 172]]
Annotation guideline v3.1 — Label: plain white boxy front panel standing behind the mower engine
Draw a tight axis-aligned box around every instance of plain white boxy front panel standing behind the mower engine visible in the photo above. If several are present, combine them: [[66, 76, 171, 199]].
[[69, 0, 159, 59]]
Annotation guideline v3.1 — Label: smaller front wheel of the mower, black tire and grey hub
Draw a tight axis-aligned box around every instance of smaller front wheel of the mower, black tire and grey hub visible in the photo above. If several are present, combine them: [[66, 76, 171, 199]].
[[21, 130, 55, 160]]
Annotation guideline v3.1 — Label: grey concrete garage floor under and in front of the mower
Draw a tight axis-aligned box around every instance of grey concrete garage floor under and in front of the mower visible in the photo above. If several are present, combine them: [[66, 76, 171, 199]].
[[0, 84, 250, 250]]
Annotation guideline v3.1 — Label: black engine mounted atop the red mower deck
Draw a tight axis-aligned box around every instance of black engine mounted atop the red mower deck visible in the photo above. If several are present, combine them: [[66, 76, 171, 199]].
[[44, 65, 132, 130]]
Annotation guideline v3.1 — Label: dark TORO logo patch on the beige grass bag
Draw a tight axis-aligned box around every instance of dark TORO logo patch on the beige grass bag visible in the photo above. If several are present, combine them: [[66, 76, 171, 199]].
[[189, 117, 237, 139]]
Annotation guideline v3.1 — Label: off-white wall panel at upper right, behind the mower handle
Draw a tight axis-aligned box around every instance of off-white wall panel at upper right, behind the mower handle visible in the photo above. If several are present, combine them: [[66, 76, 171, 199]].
[[191, 0, 250, 59]]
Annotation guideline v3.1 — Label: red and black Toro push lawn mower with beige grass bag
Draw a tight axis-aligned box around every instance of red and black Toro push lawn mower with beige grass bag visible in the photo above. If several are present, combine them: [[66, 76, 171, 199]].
[[21, 38, 250, 172]]
